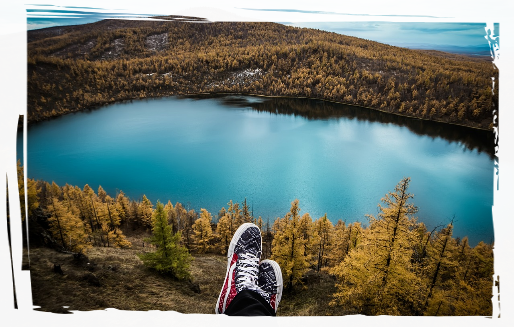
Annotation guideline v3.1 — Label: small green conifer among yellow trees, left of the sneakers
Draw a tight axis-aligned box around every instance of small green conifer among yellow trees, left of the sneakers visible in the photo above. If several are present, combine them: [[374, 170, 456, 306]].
[[139, 202, 192, 279]]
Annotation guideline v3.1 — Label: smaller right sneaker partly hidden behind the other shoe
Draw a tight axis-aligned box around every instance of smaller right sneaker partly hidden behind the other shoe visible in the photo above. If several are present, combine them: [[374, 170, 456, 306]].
[[257, 260, 284, 312]]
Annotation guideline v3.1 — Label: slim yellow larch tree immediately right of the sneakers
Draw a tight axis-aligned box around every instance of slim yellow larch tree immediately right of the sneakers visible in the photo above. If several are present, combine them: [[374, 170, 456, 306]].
[[271, 200, 309, 289]]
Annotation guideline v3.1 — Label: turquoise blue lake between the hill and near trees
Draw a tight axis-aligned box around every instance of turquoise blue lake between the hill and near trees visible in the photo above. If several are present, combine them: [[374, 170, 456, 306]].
[[1, 95, 514, 244]]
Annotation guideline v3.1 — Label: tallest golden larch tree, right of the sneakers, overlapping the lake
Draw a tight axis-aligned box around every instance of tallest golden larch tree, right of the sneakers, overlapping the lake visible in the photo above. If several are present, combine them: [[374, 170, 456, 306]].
[[332, 178, 423, 326]]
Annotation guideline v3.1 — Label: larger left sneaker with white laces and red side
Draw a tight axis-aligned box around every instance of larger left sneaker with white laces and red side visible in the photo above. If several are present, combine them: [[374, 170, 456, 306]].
[[216, 223, 262, 318]]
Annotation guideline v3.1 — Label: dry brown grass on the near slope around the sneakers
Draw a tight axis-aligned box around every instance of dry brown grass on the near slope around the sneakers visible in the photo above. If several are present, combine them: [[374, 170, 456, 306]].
[[0, 235, 351, 327]]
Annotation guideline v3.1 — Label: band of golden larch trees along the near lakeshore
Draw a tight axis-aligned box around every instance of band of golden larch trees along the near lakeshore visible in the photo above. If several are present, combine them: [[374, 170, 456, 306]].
[[0, 147, 514, 326]]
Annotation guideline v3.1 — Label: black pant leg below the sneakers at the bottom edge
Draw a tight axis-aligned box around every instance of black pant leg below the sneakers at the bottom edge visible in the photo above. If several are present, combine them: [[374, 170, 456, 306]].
[[220, 290, 278, 327]]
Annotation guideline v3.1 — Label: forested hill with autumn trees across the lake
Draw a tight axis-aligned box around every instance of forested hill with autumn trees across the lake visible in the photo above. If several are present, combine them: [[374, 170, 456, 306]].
[[0, 8, 514, 135]]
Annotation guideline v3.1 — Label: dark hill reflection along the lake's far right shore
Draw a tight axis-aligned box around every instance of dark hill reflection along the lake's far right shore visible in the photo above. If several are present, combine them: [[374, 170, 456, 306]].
[[188, 96, 514, 162]]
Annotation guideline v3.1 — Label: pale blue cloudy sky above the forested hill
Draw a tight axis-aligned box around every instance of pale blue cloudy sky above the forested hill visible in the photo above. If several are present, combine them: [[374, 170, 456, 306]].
[[0, 0, 514, 47]]
